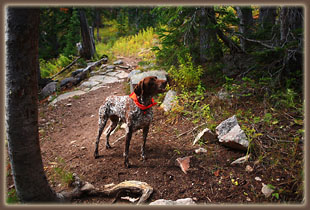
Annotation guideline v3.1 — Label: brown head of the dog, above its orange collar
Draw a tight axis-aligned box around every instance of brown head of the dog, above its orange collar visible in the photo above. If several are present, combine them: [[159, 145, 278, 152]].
[[134, 76, 167, 96]]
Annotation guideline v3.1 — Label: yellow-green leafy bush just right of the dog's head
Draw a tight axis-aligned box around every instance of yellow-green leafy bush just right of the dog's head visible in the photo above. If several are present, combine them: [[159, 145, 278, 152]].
[[168, 54, 203, 90]]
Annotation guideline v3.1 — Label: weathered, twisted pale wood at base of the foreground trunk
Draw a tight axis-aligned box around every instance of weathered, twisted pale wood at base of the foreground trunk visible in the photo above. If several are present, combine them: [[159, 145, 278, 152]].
[[58, 174, 153, 205]]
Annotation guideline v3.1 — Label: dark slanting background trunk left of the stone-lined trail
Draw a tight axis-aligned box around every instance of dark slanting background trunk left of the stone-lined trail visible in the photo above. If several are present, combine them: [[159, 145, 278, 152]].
[[79, 10, 95, 59]]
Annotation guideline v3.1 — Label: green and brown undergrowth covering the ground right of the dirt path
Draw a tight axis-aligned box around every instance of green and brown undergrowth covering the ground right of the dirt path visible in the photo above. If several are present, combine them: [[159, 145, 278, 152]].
[[167, 65, 304, 202]]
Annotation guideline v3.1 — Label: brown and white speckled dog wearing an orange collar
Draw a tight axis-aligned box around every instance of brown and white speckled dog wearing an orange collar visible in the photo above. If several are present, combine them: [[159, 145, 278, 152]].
[[94, 76, 167, 168]]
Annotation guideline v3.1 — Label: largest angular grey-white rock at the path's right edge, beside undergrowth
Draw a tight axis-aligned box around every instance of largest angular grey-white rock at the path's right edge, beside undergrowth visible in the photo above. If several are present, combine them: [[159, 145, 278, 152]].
[[216, 115, 249, 150]]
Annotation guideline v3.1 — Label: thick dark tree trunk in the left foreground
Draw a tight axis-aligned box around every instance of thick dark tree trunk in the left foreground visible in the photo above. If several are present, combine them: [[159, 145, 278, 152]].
[[6, 7, 57, 202]]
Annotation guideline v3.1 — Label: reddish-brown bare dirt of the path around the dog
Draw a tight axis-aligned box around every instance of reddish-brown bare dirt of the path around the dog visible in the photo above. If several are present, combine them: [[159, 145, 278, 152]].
[[39, 58, 274, 204]]
